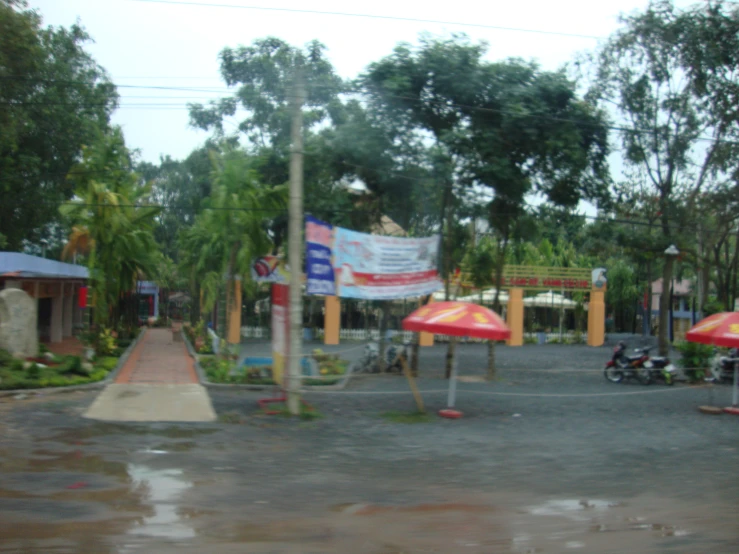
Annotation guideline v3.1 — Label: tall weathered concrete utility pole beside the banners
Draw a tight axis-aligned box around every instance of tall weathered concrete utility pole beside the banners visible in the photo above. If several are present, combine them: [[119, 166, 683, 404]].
[[287, 67, 305, 415]]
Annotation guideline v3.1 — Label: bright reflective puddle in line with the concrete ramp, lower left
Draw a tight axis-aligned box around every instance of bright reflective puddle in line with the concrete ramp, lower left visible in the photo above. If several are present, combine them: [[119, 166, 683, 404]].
[[128, 464, 195, 540]]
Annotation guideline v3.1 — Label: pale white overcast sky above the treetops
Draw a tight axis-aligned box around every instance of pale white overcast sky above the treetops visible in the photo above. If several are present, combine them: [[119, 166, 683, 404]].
[[29, 0, 689, 162]]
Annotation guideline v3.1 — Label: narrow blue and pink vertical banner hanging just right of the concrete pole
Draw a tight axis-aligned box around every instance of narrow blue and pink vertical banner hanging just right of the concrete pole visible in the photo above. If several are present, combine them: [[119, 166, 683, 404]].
[[305, 216, 336, 296]]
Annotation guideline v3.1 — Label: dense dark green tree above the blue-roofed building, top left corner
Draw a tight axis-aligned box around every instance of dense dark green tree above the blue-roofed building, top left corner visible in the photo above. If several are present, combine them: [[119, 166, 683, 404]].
[[0, 0, 118, 250]]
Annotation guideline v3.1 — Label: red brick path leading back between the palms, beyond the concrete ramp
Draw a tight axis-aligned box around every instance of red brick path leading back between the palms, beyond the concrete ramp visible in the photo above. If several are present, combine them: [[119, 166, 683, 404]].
[[115, 329, 198, 385]]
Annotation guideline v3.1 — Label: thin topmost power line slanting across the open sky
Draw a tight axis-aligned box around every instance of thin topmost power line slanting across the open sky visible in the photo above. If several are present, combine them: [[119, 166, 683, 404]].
[[125, 0, 603, 40]]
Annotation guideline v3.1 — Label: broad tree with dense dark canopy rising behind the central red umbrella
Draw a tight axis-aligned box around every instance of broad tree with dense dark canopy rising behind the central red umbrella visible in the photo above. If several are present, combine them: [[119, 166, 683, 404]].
[[362, 35, 608, 370]]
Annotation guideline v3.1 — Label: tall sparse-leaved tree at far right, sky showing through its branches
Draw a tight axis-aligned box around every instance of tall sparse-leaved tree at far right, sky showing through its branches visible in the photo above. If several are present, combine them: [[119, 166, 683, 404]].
[[590, 1, 739, 355]]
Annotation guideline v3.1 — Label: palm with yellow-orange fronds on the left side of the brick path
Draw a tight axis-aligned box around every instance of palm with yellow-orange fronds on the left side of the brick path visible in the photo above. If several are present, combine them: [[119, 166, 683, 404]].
[[60, 128, 160, 327]]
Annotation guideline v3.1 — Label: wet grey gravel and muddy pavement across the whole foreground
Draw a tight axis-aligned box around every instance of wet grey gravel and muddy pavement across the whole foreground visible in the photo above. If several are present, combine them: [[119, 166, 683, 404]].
[[0, 356, 739, 554]]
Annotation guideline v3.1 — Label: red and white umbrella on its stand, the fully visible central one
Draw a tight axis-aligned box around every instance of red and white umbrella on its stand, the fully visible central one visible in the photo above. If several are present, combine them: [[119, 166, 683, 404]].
[[403, 302, 511, 417]]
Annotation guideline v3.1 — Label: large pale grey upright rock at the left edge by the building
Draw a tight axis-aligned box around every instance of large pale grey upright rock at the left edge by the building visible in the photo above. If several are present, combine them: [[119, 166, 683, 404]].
[[0, 289, 38, 357]]
